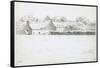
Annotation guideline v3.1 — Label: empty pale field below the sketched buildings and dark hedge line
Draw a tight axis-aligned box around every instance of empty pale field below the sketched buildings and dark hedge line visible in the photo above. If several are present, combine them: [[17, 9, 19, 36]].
[[15, 35, 96, 65]]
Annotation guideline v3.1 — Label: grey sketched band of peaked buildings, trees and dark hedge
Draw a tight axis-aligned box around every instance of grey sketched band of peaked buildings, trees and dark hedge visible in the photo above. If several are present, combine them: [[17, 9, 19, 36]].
[[16, 16, 96, 35]]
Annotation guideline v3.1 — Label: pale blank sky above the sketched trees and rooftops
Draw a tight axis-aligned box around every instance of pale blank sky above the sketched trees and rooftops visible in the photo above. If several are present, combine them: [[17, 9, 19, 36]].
[[15, 2, 96, 20]]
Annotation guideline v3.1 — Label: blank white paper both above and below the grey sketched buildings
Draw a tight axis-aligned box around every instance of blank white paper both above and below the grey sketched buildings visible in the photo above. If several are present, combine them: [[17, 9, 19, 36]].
[[15, 2, 96, 66]]
